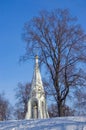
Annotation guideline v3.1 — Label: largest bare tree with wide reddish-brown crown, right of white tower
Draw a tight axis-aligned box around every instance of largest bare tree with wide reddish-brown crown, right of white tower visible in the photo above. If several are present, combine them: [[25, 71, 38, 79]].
[[23, 9, 86, 116]]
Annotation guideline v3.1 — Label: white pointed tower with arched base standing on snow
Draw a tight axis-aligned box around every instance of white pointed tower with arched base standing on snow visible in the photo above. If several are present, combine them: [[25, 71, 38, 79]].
[[26, 56, 49, 119]]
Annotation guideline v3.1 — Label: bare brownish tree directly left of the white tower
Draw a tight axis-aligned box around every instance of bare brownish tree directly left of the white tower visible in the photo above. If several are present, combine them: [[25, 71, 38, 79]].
[[14, 83, 31, 119]]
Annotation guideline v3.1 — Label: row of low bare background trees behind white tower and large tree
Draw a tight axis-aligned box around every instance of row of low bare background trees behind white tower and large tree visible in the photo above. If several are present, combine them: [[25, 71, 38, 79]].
[[0, 83, 86, 121]]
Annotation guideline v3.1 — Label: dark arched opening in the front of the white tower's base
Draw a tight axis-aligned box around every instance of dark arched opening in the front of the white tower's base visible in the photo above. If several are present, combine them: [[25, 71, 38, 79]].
[[32, 101, 38, 119]]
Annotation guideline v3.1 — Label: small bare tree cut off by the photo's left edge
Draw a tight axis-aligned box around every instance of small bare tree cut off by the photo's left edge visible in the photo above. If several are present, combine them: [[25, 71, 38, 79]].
[[0, 94, 11, 121]]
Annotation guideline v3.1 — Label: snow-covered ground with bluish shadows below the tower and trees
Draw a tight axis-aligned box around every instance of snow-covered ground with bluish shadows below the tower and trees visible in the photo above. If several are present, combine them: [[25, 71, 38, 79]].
[[0, 117, 86, 130]]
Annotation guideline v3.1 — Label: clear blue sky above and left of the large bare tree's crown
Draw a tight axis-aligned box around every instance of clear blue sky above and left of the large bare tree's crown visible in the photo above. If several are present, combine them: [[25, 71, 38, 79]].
[[0, 0, 86, 104]]
